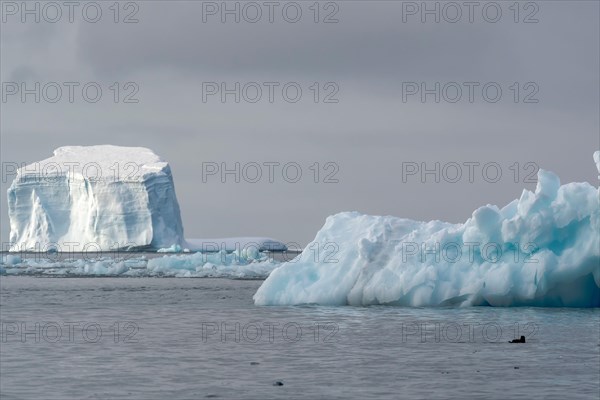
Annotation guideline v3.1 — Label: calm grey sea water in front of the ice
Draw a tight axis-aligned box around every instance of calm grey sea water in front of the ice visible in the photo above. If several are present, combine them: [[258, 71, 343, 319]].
[[0, 276, 600, 400]]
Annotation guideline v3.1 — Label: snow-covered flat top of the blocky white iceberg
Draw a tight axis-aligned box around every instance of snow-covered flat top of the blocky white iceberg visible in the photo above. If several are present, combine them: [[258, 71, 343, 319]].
[[17, 145, 169, 181]]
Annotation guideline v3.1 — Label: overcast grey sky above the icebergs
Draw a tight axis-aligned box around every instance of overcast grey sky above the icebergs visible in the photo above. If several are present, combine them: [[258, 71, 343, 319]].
[[0, 0, 600, 245]]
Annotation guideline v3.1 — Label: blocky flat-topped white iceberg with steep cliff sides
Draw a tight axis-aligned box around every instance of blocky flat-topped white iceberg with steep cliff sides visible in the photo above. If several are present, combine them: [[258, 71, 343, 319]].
[[8, 145, 184, 251]]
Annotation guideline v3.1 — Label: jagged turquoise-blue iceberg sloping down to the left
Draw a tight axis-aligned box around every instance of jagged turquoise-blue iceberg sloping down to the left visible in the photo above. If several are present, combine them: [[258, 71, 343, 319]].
[[254, 152, 600, 307]]
